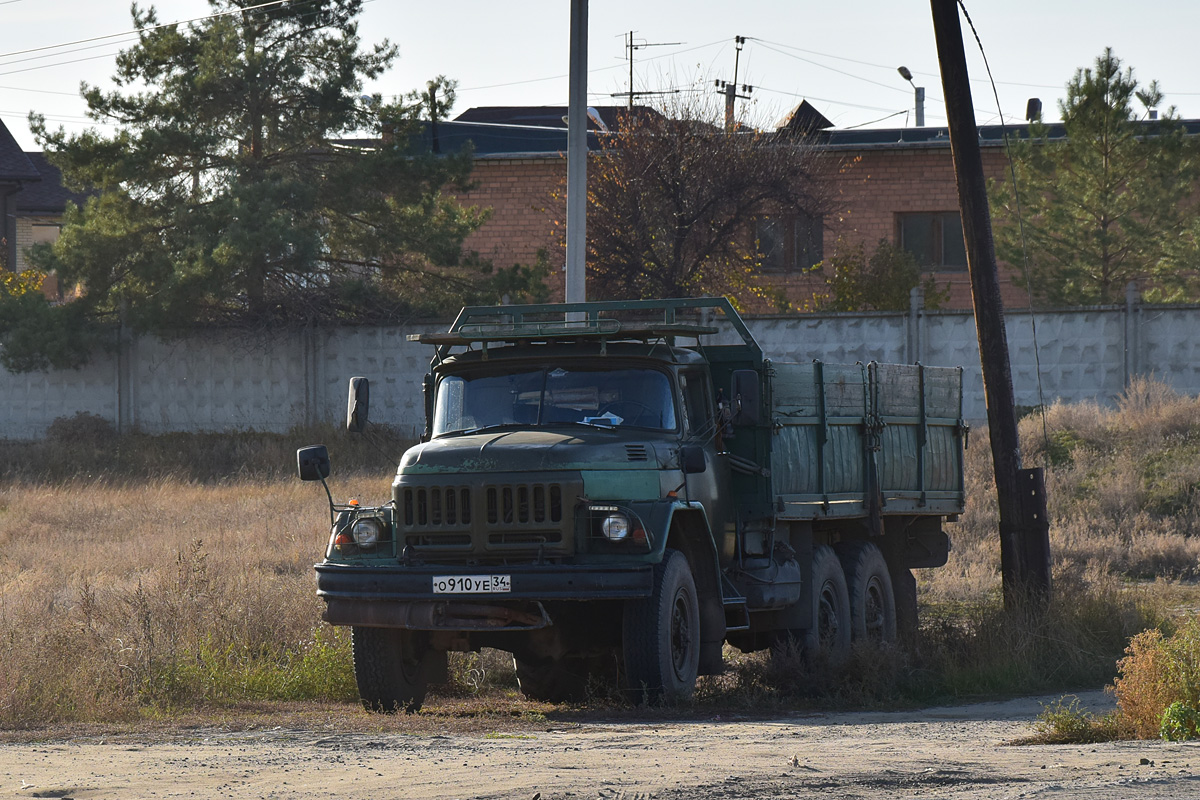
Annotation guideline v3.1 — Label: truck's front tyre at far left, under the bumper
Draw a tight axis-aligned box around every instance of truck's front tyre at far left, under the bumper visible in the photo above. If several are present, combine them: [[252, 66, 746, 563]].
[[350, 626, 430, 714]]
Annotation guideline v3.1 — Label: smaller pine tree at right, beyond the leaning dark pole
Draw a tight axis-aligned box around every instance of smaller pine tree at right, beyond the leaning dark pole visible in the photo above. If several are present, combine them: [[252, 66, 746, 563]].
[[989, 49, 1200, 306]]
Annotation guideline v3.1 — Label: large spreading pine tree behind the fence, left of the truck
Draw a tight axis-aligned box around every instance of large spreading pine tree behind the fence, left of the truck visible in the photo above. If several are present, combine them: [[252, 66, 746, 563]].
[[0, 0, 486, 368]]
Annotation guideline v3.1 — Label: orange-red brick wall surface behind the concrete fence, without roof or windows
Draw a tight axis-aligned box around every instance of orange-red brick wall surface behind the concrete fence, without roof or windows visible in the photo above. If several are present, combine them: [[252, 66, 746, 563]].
[[460, 142, 1027, 312]]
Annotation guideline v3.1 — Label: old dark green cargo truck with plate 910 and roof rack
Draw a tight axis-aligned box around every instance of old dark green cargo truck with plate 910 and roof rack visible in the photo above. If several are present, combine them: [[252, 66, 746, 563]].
[[298, 299, 967, 711]]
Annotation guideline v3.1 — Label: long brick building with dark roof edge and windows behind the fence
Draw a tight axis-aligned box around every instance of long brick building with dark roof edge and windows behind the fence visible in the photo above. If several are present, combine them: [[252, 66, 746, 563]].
[[439, 108, 1051, 308]]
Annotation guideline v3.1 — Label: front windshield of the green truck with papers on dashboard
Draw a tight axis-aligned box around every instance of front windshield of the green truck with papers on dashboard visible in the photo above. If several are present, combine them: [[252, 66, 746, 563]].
[[433, 366, 676, 437]]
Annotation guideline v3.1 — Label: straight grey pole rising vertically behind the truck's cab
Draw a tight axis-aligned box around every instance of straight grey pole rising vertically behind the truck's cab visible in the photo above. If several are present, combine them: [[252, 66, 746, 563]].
[[565, 0, 588, 302]]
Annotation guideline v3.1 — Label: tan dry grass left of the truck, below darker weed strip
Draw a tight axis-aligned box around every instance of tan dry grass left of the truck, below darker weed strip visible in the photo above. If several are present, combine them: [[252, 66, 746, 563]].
[[0, 479, 374, 727]]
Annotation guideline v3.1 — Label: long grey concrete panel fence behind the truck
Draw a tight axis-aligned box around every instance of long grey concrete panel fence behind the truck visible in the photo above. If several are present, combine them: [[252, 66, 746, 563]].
[[0, 286, 1200, 439]]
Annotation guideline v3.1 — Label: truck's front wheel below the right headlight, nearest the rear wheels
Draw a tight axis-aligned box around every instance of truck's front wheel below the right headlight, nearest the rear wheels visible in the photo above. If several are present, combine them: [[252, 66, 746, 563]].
[[622, 548, 700, 704]]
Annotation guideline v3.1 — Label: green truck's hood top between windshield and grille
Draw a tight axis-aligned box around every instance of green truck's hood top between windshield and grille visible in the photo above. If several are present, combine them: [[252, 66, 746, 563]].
[[400, 429, 667, 475]]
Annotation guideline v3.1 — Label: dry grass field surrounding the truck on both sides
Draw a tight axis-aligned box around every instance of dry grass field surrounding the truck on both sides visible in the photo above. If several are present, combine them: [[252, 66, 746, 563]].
[[0, 383, 1200, 729]]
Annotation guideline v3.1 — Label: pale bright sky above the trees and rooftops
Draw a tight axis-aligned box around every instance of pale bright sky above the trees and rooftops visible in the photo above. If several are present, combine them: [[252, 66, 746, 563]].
[[0, 0, 1200, 150]]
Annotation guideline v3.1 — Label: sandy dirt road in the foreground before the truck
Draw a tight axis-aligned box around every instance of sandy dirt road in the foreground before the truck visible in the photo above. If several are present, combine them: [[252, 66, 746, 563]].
[[0, 693, 1200, 800]]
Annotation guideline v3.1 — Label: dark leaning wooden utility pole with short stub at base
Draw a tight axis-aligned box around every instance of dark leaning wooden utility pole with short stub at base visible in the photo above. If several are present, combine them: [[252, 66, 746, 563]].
[[930, 0, 1050, 609]]
